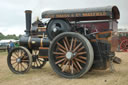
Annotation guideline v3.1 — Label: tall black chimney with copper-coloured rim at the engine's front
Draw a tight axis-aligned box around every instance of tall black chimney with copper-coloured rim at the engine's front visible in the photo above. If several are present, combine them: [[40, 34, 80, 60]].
[[25, 10, 32, 36]]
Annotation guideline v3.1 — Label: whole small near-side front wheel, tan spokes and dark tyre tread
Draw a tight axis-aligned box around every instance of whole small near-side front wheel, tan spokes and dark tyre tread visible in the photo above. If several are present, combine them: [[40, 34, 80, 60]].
[[7, 46, 32, 74]]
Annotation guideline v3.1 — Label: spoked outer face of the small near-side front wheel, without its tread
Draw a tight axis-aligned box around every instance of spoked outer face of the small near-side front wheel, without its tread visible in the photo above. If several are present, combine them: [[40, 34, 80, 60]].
[[9, 48, 30, 73]]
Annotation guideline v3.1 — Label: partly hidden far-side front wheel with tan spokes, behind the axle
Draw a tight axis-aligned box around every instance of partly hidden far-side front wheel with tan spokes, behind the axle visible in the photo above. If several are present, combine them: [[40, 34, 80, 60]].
[[32, 50, 46, 69]]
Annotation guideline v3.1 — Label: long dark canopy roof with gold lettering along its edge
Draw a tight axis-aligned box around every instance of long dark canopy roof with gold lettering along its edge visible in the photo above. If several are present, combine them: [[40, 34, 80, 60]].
[[42, 6, 120, 20]]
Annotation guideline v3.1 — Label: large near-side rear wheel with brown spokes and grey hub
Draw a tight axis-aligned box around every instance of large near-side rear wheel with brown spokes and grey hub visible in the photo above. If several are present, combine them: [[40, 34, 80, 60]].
[[48, 32, 94, 78]]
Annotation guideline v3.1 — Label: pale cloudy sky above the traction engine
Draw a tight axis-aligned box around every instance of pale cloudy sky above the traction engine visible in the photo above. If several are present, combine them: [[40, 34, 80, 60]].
[[0, 0, 128, 35]]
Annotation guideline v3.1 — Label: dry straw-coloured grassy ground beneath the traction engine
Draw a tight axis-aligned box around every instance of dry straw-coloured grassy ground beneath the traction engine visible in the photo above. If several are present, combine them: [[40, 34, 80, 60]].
[[0, 52, 128, 85]]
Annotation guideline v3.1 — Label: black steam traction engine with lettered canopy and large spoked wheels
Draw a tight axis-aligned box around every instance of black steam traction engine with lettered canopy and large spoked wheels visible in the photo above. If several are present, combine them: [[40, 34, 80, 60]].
[[7, 6, 120, 78]]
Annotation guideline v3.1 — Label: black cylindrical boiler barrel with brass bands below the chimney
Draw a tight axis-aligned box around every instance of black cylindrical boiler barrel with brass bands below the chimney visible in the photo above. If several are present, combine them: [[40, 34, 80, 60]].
[[19, 36, 50, 49]]
